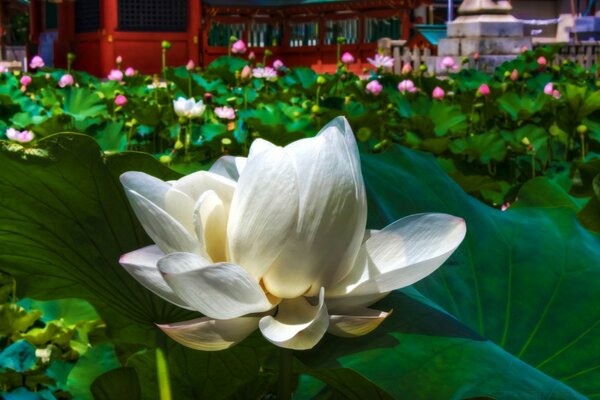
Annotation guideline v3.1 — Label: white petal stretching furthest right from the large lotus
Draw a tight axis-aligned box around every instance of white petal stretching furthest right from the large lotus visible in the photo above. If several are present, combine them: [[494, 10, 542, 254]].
[[328, 214, 466, 297]]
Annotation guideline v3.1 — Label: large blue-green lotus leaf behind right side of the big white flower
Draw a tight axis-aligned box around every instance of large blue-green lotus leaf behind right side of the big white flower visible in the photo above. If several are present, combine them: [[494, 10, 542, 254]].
[[305, 147, 600, 399]]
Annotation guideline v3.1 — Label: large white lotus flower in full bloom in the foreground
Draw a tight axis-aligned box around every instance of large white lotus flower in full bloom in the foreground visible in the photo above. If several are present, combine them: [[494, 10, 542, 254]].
[[120, 118, 466, 350]]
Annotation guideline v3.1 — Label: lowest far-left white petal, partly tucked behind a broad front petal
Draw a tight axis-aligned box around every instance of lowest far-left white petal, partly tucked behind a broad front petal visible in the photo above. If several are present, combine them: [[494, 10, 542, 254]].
[[119, 246, 195, 309]]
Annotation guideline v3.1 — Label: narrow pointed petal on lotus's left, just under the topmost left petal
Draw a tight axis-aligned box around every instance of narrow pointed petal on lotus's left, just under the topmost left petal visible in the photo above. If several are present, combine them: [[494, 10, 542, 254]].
[[125, 190, 198, 254]]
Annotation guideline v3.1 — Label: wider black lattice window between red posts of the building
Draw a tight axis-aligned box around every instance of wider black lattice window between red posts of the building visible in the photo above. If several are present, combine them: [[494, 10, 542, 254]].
[[119, 0, 188, 32]]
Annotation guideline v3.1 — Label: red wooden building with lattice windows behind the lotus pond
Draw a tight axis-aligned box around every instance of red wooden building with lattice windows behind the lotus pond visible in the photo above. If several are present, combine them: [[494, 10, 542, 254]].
[[30, 0, 431, 75]]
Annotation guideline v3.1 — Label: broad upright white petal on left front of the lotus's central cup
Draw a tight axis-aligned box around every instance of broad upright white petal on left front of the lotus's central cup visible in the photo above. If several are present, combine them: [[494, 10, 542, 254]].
[[227, 148, 298, 282]]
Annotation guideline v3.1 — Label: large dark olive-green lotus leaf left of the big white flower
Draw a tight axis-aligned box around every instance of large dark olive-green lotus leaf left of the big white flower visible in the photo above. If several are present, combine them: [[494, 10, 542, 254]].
[[0, 134, 272, 399]]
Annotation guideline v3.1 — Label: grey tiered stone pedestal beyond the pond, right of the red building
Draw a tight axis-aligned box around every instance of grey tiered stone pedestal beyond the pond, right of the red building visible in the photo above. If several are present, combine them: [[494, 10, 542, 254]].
[[435, 0, 532, 72]]
